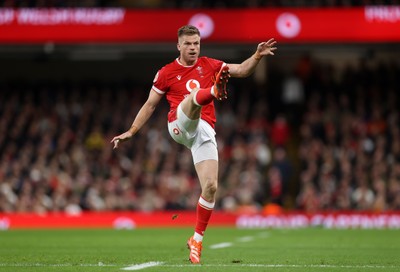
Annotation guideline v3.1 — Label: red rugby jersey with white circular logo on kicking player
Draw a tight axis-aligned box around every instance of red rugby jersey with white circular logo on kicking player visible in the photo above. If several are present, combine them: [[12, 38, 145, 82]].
[[152, 57, 223, 127]]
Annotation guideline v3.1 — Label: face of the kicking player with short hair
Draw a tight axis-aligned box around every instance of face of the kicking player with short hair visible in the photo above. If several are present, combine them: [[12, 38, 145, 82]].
[[178, 35, 200, 65]]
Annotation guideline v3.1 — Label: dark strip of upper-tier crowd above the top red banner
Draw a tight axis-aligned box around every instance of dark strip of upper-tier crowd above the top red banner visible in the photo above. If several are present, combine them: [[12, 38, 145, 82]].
[[1, 0, 400, 9]]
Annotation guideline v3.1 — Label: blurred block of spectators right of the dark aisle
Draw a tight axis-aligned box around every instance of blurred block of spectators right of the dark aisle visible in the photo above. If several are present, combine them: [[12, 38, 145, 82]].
[[297, 58, 400, 211]]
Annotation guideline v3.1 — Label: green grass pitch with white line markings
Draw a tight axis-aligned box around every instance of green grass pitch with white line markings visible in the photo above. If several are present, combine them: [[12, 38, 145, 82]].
[[0, 227, 400, 272]]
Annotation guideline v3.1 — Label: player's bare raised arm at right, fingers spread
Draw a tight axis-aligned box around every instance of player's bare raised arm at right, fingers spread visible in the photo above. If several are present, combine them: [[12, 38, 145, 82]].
[[228, 38, 276, 77]]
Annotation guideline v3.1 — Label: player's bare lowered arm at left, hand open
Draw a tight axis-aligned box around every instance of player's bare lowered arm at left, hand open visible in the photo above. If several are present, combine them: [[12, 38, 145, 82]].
[[111, 91, 162, 149]]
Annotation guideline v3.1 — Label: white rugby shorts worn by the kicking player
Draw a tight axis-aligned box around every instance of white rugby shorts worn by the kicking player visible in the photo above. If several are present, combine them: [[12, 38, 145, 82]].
[[168, 105, 218, 164]]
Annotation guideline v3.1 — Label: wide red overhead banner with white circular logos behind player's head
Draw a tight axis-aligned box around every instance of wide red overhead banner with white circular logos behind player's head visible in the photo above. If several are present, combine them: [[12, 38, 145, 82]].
[[0, 6, 400, 44]]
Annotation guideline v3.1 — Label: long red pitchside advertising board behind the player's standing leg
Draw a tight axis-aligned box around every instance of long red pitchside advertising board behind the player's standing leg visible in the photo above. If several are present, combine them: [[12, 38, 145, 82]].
[[0, 211, 400, 230]]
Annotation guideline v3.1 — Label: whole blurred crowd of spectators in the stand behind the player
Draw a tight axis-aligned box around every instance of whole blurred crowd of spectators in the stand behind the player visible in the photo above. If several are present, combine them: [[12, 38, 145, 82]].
[[0, 57, 400, 214]]
